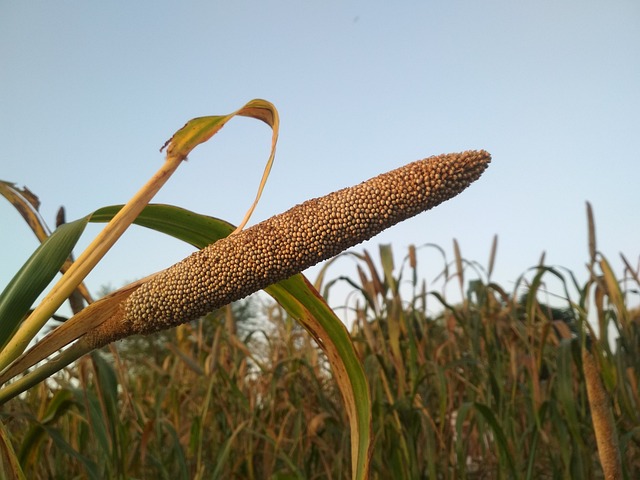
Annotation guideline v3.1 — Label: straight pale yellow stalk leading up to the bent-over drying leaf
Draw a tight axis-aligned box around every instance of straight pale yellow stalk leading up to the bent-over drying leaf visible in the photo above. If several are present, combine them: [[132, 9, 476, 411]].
[[0, 155, 185, 371]]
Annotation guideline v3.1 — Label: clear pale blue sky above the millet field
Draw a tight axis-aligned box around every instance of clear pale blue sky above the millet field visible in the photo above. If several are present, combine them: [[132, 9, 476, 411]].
[[0, 0, 640, 320]]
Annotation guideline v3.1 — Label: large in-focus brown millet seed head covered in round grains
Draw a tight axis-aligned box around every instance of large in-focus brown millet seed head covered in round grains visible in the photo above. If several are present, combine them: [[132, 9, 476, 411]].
[[87, 150, 491, 344]]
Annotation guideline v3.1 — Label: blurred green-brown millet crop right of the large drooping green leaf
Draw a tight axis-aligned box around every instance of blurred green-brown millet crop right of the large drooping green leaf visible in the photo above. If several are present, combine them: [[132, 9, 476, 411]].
[[314, 205, 640, 479]]
